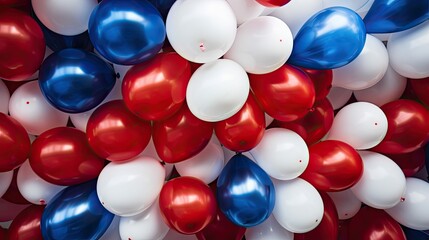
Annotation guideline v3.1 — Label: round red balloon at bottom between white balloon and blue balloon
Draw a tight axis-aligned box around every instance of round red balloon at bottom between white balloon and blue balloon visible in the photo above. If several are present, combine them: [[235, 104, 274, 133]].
[[159, 177, 216, 234]]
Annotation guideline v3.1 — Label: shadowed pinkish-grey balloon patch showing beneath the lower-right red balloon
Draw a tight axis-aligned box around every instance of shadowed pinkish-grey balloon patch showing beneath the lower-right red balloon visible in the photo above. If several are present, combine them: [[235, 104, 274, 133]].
[[328, 189, 362, 220]]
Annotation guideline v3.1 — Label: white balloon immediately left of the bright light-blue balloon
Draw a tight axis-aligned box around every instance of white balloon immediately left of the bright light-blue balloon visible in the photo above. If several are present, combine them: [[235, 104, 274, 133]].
[[224, 16, 293, 74]]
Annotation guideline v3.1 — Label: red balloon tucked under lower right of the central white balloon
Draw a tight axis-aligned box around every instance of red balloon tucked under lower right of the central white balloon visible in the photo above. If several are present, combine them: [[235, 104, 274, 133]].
[[214, 93, 265, 152]]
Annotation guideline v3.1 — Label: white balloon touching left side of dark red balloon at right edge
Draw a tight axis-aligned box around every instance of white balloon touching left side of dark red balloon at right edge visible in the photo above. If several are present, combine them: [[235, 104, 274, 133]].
[[327, 102, 387, 150]]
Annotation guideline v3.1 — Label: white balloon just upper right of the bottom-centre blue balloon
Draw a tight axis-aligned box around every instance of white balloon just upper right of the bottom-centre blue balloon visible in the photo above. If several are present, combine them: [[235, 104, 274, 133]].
[[250, 128, 309, 180]]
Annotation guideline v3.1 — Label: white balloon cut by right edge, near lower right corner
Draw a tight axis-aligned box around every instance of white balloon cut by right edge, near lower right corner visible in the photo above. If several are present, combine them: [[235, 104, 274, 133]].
[[385, 178, 429, 230]]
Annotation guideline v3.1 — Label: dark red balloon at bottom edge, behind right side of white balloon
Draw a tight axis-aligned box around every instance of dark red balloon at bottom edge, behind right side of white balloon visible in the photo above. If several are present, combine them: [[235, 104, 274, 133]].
[[293, 192, 339, 240]]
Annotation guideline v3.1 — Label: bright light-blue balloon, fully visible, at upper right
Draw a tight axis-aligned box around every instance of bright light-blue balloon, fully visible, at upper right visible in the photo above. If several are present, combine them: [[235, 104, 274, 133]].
[[288, 7, 366, 69]]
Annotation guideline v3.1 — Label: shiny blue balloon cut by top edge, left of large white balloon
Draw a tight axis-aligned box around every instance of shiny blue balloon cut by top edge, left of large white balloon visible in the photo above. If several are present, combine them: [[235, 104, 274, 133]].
[[88, 0, 166, 65]]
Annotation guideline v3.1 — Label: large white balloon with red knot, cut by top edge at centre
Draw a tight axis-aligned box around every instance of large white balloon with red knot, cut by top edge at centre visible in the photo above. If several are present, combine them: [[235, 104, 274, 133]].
[[166, 0, 237, 63]]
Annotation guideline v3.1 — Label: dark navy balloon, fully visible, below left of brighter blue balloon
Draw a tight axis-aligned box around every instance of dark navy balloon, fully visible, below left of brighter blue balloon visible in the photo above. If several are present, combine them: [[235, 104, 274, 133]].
[[39, 48, 116, 113]]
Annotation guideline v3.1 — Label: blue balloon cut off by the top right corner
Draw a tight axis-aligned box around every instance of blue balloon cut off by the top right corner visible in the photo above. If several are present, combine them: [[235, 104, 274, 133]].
[[363, 0, 429, 33]]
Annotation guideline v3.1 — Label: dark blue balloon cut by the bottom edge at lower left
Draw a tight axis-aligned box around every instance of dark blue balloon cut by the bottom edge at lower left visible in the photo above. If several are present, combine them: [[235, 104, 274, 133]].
[[40, 181, 114, 240]]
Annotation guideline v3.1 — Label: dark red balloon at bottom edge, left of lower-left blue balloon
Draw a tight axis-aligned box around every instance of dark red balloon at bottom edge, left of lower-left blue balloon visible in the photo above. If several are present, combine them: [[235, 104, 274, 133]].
[[8, 205, 45, 240]]
